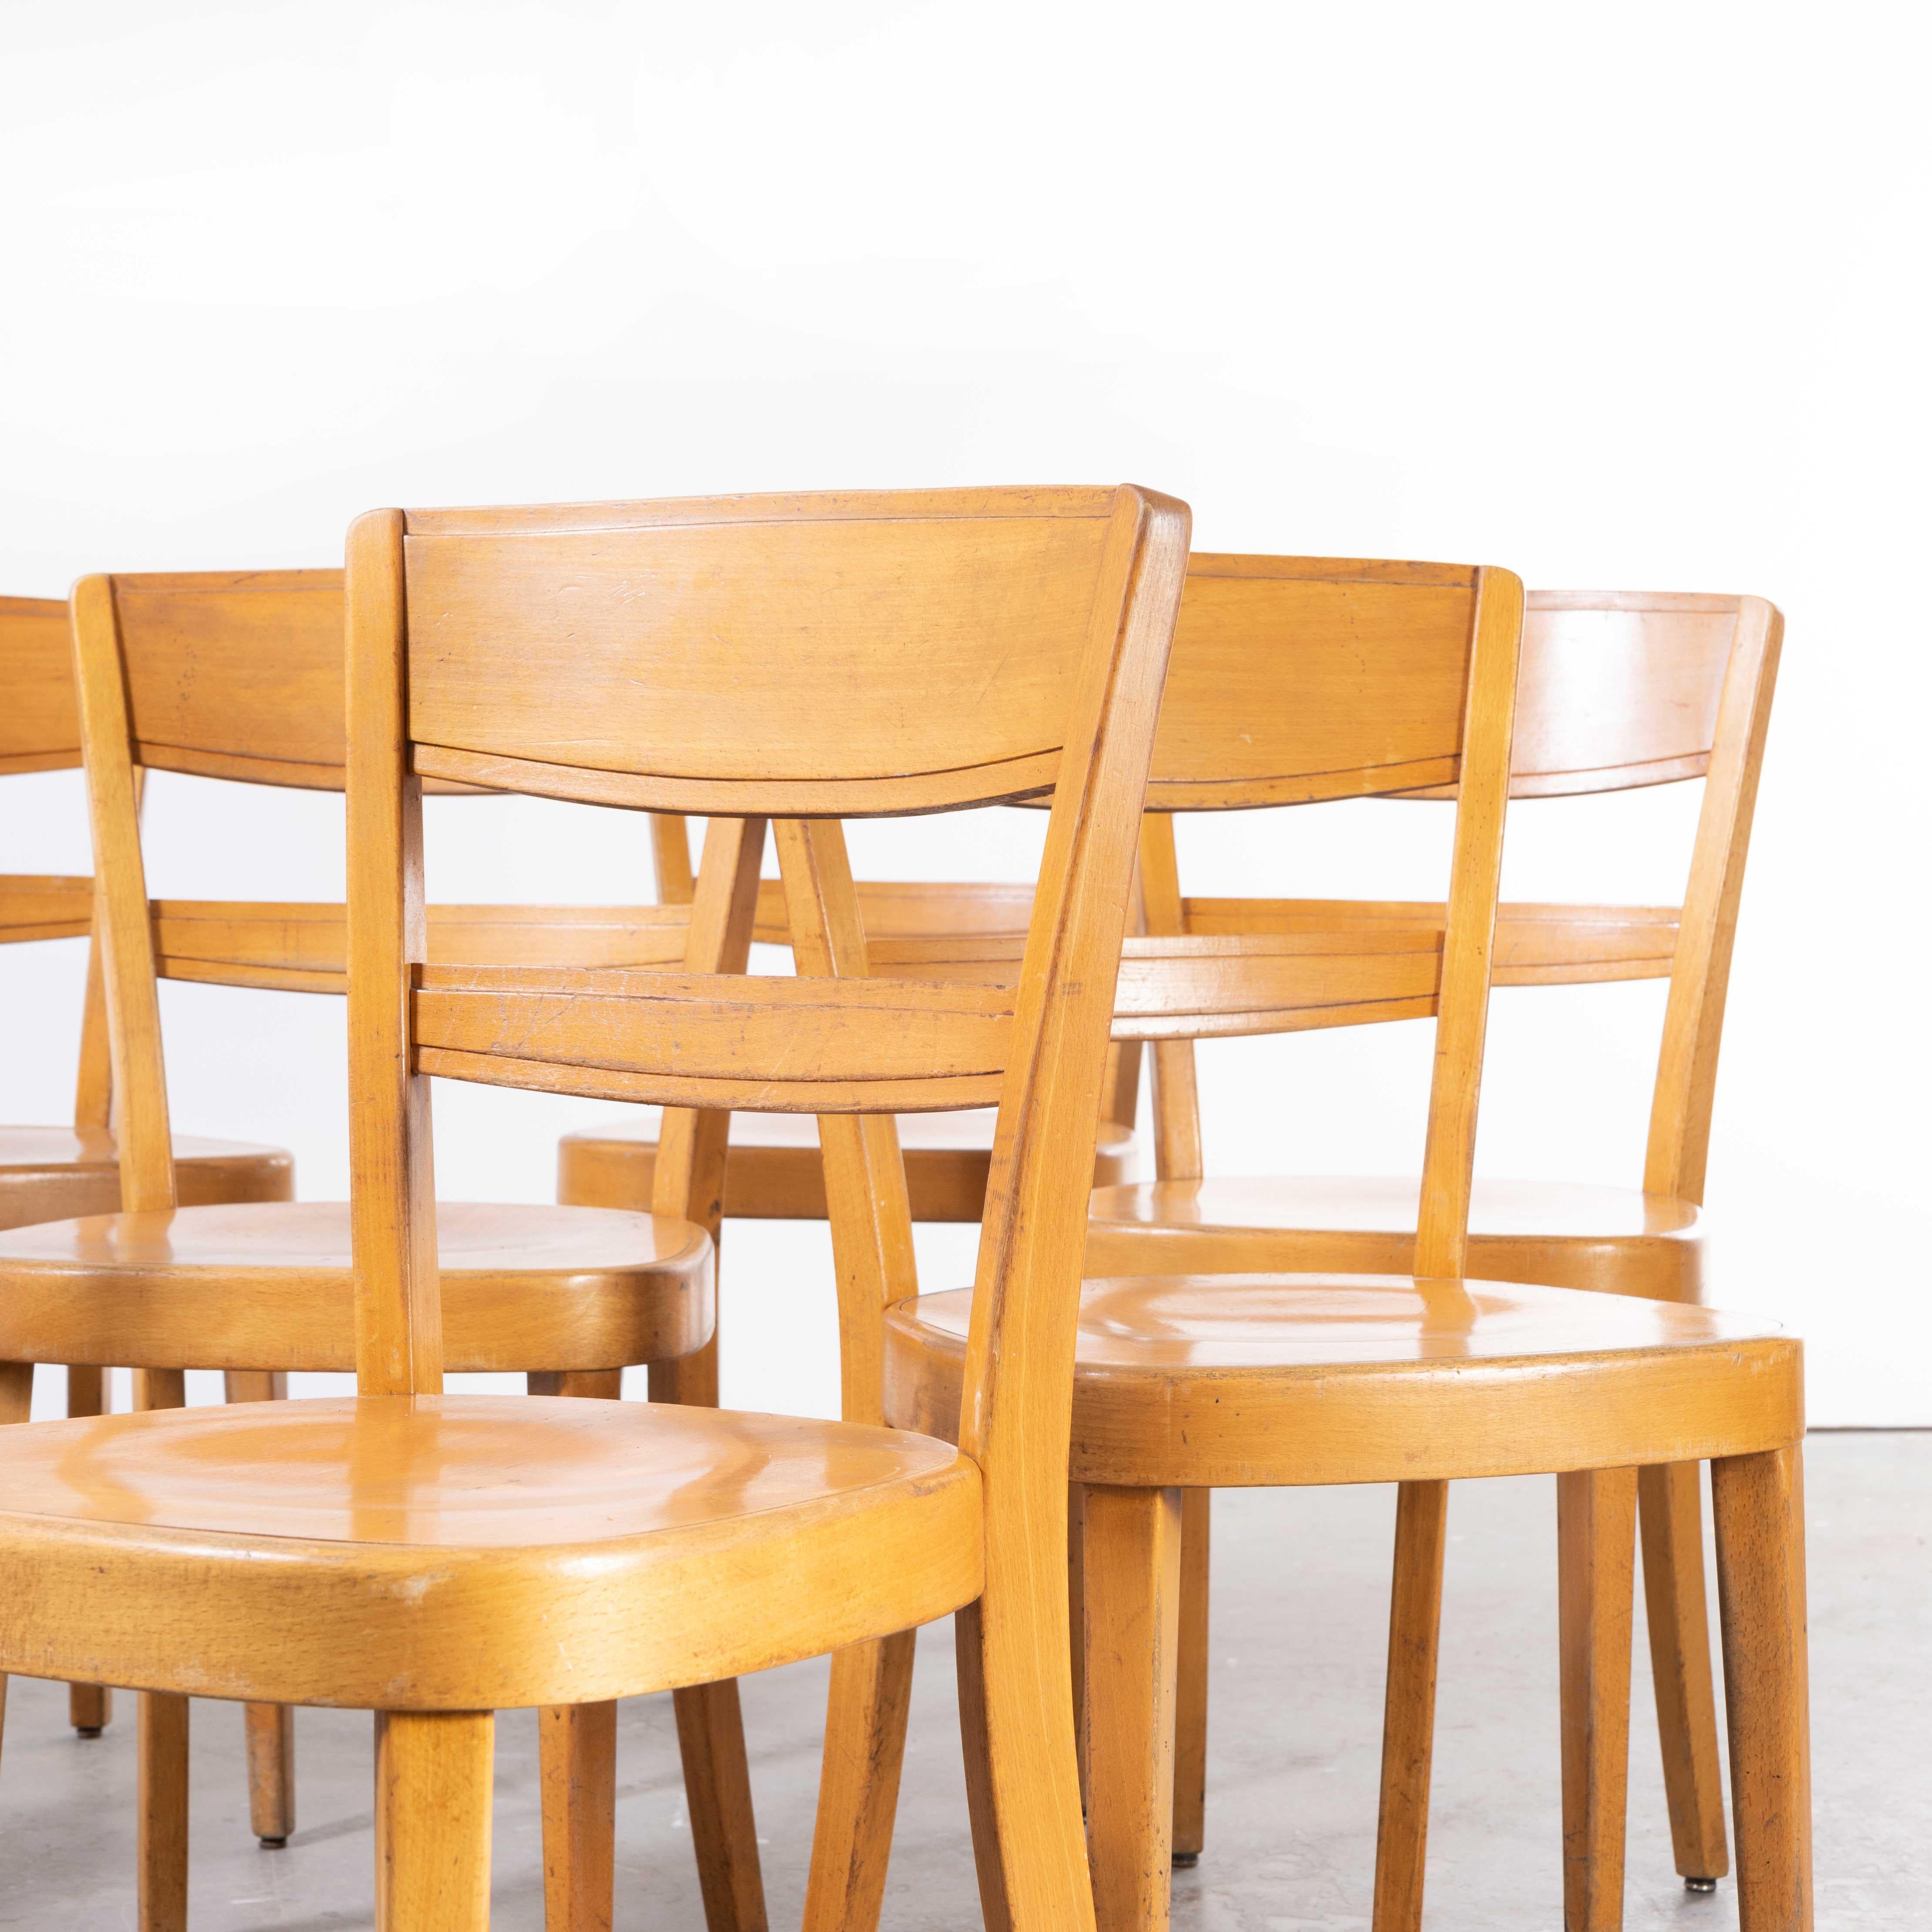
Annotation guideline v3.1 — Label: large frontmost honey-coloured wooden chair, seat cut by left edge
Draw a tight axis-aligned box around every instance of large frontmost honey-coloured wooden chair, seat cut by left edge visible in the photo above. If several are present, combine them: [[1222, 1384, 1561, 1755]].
[[0, 489, 1188, 1932]]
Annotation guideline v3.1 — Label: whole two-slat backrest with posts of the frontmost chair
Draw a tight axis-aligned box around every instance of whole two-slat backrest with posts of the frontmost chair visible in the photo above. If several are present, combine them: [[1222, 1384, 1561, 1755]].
[[348, 487, 1188, 1546]]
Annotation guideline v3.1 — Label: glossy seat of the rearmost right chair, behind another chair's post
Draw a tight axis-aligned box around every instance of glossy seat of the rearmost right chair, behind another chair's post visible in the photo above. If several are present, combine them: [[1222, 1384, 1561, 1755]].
[[1088, 1175, 1704, 1302]]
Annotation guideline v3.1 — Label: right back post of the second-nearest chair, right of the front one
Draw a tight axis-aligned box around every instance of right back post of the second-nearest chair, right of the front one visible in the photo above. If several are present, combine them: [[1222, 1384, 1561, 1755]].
[[1416, 570, 1524, 1277]]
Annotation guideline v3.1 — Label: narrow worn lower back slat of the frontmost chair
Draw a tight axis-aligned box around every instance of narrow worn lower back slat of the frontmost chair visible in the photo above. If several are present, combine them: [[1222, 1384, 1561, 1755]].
[[413, 966, 1014, 1113]]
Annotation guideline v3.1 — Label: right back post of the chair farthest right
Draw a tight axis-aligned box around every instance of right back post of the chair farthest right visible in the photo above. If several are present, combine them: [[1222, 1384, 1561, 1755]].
[[1644, 597, 1785, 1204]]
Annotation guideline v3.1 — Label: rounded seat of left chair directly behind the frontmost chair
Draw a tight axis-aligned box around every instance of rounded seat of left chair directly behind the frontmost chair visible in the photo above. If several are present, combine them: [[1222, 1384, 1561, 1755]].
[[0, 1202, 715, 1372]]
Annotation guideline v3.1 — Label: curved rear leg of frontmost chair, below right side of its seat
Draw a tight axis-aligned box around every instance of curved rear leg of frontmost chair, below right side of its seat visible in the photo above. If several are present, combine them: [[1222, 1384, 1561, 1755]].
[[953, 1596, 1093, 1932]]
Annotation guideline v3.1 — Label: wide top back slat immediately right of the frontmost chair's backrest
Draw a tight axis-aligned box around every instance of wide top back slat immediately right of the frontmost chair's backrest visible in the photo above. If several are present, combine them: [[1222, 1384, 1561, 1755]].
[[1147, 554, 1476, 812]]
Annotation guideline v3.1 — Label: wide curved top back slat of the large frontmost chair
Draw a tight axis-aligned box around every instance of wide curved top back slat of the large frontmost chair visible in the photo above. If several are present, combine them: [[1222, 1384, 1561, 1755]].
[[404, 491, 1113, 815]]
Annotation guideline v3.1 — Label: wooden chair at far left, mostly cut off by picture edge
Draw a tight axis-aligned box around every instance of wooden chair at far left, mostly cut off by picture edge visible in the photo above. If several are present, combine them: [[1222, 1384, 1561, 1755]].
[[0, 597, 295, 1737]]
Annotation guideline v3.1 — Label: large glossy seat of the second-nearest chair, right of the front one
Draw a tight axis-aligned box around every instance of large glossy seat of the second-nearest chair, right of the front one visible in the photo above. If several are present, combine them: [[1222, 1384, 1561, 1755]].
[[885, 1275, 1805, 1488]]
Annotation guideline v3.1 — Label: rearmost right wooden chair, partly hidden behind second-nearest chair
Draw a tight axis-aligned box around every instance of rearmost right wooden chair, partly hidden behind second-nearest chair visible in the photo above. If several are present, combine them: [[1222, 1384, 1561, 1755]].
[[1088, 583, 1783, 1892]]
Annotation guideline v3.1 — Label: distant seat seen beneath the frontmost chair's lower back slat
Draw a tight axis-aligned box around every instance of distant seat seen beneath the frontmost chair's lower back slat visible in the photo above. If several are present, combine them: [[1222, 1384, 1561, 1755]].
[[557, 1107, 1134, 1221]]
